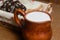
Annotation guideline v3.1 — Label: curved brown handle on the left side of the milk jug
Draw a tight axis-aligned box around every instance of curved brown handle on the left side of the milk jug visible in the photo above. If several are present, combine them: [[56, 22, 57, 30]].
[[14, 9, 25, 27]]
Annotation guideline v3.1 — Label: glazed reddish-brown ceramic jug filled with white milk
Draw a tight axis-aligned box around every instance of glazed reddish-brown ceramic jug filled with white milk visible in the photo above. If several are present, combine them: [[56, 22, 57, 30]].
[[14, 9, 52, 40]]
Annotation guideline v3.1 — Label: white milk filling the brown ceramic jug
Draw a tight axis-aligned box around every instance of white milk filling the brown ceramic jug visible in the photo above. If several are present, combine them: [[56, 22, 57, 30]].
[[26, 12, 51, 22]]
